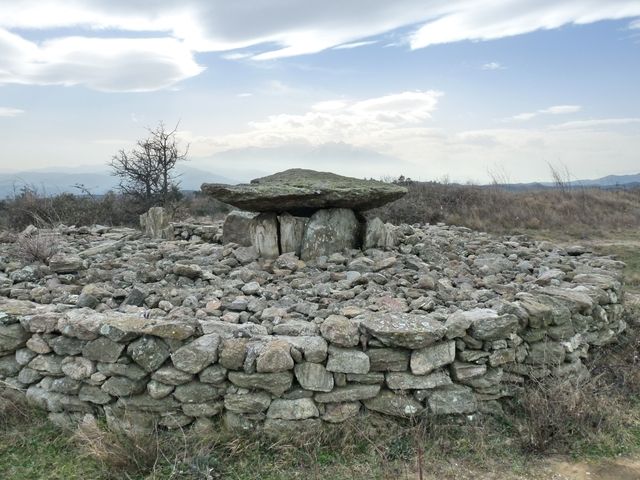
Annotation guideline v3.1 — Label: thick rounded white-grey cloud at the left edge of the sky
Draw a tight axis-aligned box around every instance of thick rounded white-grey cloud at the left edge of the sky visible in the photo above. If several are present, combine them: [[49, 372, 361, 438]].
[[0, 29, 203, 92]]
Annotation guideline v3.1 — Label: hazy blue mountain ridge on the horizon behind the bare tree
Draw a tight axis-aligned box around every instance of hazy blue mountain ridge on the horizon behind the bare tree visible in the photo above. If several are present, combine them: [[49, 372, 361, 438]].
[[0, 165, 238, 198]]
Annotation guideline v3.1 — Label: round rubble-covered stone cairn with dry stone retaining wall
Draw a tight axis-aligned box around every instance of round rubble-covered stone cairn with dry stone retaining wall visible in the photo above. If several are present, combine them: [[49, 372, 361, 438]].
[[0, 221, 625, 431]]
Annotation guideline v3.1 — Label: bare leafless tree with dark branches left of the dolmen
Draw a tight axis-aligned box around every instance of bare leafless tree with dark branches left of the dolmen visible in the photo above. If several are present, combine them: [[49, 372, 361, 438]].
[[109, 122, 189, 208]]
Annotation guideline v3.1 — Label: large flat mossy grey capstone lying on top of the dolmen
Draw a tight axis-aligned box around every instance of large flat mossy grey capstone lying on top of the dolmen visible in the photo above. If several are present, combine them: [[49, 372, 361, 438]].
[[202, 168, 407, 214]]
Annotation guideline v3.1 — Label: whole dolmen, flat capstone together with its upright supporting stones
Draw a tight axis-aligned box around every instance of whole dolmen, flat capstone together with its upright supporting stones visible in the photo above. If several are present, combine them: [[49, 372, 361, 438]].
[[202, 168, 407, 260]]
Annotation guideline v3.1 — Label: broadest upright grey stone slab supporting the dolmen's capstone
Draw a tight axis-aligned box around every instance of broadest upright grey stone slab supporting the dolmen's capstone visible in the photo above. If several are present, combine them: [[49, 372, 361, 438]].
[[300, 208, 360, 260]]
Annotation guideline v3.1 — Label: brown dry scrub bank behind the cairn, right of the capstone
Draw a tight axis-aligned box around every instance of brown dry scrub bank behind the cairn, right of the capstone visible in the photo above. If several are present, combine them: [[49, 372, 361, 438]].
[[371, 182, 640, 236]]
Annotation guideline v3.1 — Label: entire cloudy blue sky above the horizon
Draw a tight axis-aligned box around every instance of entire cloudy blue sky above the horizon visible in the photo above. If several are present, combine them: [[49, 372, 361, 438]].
[[0, 0, 640, 183]]
